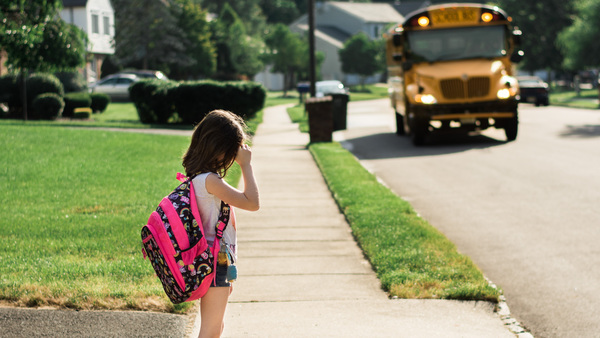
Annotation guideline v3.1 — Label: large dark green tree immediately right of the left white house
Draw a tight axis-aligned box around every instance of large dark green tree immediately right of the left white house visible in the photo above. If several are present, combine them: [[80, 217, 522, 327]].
[[111, 0, 193, 74]]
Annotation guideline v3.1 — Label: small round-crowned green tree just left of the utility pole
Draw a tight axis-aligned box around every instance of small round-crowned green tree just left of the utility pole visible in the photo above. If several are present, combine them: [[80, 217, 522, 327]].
[[264, 23, 308, 96]]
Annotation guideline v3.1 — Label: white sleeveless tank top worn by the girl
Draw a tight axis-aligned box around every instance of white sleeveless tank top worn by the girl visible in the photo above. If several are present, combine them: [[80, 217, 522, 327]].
[[192, 173, 237, 258]]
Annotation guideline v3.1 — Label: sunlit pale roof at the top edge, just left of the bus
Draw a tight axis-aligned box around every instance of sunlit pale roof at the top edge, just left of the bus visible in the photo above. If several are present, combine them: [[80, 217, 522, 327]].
[[326, 1, 404, 23]]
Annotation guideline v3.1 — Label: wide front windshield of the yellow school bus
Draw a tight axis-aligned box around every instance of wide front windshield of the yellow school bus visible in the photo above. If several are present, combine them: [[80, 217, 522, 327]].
[[407, 26, 508, 62]]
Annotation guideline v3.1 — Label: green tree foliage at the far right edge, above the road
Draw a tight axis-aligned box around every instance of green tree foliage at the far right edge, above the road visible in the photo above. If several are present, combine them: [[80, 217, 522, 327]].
[[558, 0, 600, 70]]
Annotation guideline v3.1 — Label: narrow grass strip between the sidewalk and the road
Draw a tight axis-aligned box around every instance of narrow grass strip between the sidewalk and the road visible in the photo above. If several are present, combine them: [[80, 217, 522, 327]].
[[310, 143, 500, 302]]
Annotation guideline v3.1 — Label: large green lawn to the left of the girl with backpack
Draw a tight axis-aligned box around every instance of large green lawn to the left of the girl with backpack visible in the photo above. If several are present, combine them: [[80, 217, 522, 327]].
[[0, 126, 195, 311]]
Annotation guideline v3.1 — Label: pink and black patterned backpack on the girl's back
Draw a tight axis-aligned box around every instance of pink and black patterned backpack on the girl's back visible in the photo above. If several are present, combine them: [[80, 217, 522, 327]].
[[142, 173, 232, 304]]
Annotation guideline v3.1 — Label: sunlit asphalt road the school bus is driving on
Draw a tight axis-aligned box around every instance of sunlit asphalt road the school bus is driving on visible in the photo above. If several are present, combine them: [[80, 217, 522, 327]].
[[334, 99, 600, 337]]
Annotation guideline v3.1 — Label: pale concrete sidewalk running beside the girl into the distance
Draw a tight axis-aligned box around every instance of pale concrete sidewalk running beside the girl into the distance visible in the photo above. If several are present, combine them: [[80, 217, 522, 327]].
[[190, 106, 515, 337]]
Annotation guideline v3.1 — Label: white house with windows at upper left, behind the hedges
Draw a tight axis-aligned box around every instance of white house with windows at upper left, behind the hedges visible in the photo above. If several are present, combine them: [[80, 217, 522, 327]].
[[60, 0, 115, 82]]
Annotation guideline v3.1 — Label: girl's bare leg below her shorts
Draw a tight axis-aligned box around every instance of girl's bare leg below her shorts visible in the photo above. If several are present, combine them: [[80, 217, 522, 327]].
[[198, 287, 231, 338]]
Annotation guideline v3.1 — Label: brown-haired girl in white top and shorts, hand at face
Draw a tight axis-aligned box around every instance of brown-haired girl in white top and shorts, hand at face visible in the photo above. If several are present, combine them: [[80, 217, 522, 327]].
[[183, 110, 260, 337]]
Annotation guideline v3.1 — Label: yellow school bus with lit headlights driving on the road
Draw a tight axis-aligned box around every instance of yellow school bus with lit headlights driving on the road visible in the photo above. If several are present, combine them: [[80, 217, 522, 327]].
[[384, 4, 523, 145]]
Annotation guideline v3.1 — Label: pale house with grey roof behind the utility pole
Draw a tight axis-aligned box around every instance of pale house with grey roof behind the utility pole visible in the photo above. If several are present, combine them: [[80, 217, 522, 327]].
[[255, 1, 404, 90]]
